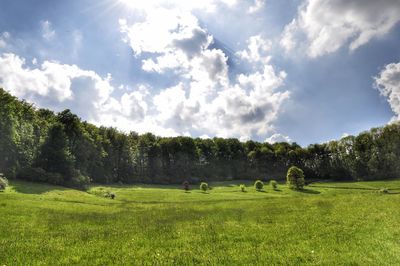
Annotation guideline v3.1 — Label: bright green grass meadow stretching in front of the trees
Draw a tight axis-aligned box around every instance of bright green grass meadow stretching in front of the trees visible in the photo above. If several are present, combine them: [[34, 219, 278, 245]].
[[0, 181, 400, 266]]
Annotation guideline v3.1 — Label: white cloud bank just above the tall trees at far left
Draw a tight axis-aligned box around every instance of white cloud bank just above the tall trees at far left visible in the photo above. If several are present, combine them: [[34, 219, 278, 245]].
[[0, 53, 113, 120]]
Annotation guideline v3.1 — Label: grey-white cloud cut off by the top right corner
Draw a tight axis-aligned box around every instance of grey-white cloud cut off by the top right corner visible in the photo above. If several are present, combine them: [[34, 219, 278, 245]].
[[281, 0, 400, 57]]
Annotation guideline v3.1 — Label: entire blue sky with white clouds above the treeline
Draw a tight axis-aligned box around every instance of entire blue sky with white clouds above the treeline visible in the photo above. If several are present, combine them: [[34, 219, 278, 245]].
[[0, 0, 400, 145]]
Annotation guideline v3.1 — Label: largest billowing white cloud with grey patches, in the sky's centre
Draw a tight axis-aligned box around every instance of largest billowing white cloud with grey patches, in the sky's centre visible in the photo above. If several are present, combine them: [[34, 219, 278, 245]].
[[120, 8, 289, 139]]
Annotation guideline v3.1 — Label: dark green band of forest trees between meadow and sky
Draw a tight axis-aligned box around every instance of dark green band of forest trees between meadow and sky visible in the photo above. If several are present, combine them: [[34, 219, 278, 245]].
[[0, 89, 400, 187]]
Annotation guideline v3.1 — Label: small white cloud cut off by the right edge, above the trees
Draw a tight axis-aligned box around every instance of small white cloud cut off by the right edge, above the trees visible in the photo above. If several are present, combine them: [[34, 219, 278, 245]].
[[375, 62, 400, 120]]
